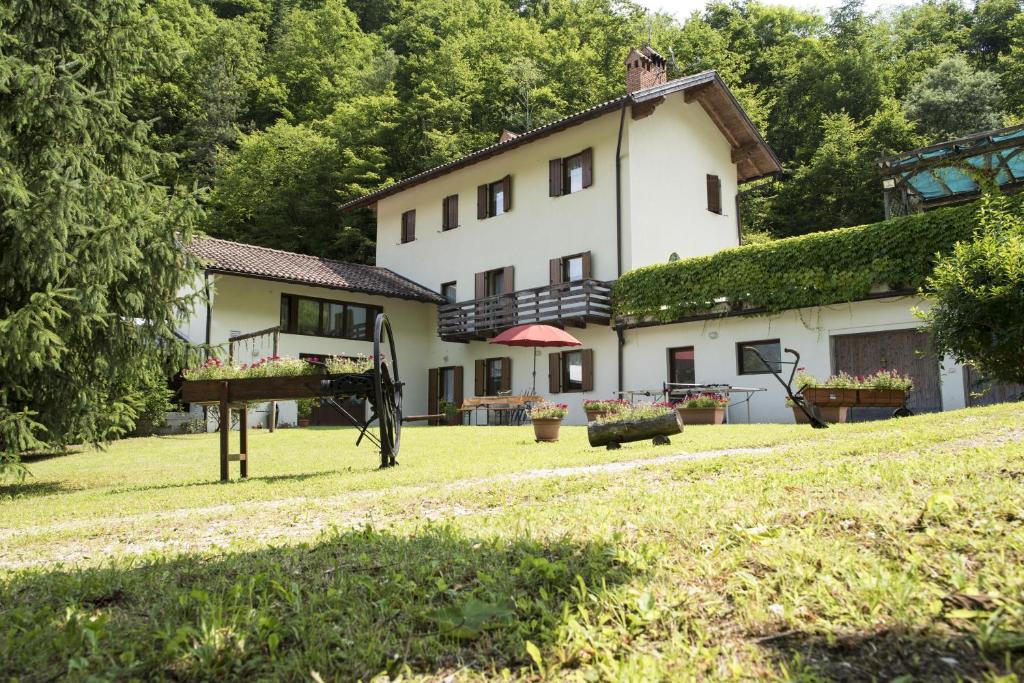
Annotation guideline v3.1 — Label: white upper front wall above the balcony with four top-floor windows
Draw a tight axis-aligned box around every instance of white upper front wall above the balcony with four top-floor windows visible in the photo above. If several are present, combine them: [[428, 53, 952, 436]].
[[377, 113, 618, 301]]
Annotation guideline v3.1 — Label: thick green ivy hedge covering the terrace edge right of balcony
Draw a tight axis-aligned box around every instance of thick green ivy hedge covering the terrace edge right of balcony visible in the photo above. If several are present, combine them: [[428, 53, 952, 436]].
[[612, 196, 1024, 323]]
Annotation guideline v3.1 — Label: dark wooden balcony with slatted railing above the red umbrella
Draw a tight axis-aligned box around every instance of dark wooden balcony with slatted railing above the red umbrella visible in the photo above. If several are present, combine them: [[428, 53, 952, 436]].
[[437, 280, 611, 342]]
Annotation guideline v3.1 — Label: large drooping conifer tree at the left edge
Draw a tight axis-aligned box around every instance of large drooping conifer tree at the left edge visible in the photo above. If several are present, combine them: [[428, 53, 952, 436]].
[[0, 0, 200, 479]]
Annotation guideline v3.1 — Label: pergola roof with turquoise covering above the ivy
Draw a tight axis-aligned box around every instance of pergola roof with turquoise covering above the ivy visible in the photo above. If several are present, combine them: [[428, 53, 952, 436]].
[[879, 125, 1024, 208]]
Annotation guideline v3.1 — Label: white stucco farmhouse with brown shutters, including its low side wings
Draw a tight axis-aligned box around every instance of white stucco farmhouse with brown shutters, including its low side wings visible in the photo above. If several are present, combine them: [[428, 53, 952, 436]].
[[182, 48, 999, 424]]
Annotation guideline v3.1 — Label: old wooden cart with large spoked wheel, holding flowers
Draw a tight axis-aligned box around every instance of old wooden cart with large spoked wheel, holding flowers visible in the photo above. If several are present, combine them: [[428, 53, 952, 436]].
[[181, 313, 402, 481]]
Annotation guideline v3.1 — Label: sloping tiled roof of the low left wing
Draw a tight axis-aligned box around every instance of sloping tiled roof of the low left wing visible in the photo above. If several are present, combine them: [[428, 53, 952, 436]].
[[188, 238, 444, 303]]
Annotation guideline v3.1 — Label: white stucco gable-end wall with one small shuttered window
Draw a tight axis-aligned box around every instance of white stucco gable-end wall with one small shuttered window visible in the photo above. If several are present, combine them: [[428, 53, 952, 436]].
[[624, 93, 739, 270]]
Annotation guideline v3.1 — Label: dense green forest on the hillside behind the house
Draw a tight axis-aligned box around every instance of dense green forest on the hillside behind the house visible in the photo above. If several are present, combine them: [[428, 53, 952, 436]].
[[133, 0, 1024, 262]]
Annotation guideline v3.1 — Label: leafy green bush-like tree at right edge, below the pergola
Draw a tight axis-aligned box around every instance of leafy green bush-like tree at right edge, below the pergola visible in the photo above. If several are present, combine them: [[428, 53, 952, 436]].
[[923, 194, 1024, 383]]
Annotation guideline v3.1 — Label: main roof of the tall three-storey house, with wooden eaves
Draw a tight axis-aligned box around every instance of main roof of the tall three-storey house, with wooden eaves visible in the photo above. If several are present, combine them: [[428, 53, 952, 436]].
[[340, 71, 782, 211]]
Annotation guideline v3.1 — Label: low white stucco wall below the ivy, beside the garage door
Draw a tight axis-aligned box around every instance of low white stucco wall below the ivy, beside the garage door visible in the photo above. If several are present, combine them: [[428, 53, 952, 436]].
[[624, 297, 965, 423]]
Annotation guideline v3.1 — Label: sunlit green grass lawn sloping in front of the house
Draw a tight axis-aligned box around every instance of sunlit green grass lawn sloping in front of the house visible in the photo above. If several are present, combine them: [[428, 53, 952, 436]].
[[0, 404, 1024, 681]]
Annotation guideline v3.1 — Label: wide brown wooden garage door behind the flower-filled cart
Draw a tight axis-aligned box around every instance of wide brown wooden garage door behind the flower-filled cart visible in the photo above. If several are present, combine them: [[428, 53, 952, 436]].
[[831, 330, 942, 422]]
